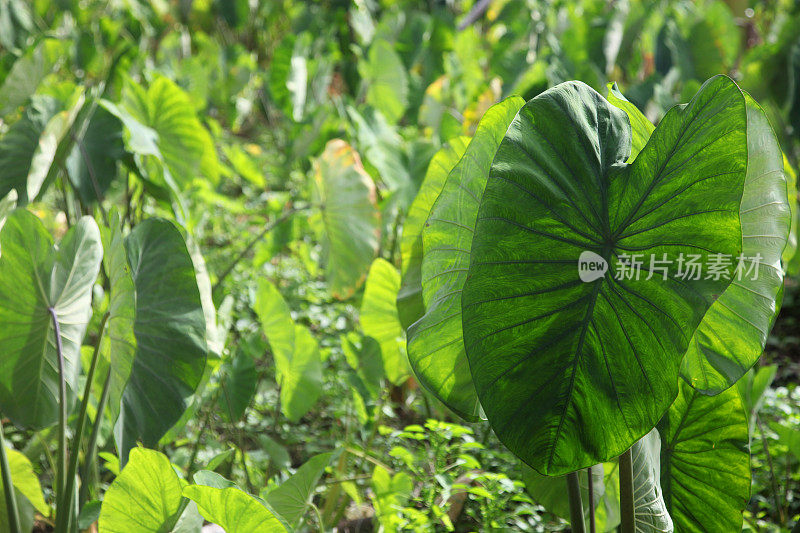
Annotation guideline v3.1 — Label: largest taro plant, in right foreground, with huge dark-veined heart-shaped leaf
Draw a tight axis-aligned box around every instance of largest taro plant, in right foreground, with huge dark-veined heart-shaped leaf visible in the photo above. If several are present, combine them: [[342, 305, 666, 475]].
[[400, 76, 790, 532]]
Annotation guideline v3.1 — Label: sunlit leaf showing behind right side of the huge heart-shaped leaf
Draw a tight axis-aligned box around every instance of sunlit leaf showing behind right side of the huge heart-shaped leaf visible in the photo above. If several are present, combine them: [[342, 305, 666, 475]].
[[681, 96, 791, 394]]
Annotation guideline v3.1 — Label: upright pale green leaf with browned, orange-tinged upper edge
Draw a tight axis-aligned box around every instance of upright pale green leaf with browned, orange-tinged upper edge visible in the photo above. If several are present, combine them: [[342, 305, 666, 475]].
[[314, 139, 380, 298]]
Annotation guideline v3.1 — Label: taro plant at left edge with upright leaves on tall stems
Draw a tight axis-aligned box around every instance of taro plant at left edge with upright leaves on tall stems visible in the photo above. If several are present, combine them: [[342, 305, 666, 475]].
[[0, 208, 207, 533]]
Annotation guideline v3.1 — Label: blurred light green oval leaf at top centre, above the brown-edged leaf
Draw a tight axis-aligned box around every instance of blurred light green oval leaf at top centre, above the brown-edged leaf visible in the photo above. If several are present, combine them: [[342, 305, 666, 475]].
[[364, 39, 408, 123]]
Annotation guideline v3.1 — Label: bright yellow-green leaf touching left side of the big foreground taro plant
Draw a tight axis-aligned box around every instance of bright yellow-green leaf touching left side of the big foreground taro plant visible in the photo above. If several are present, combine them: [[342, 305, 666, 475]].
[[360, 258, 411, 385]]
